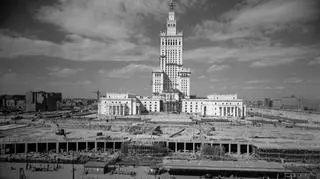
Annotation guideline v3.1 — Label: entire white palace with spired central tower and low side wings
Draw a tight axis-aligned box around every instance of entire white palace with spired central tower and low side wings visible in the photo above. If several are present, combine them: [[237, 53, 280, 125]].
[[98, 0, 245, 117]]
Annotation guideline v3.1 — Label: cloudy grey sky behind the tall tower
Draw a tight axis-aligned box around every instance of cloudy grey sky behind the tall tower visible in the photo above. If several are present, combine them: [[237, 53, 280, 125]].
[[0, 0, 320, 99]]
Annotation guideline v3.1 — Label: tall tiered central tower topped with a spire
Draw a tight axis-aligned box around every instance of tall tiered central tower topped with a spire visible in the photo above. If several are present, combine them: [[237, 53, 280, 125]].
[[152, 0, 191, 98]]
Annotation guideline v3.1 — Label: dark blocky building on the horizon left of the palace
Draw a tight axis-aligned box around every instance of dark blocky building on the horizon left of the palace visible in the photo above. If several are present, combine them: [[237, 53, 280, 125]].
[[26, 91, 62, 112]]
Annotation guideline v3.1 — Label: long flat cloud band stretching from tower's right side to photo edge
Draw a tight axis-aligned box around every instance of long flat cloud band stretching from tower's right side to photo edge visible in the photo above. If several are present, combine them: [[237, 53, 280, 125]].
[[184, 45, 320, 67]]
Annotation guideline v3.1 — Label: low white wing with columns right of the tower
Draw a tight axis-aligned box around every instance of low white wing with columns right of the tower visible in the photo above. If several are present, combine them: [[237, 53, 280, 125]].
[[182, 94, 246, 117]]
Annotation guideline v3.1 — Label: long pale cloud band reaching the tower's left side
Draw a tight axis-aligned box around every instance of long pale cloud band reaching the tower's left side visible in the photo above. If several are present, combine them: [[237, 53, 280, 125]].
[[0, 31, 158, 61]]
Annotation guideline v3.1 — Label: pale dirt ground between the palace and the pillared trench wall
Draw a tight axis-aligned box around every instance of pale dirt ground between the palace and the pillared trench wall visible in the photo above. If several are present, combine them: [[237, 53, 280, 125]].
[[0, 112, 320, 148]]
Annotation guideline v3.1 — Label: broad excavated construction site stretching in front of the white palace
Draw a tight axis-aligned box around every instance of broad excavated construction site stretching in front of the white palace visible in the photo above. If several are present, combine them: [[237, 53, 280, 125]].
[[0, 109, 320, 178]]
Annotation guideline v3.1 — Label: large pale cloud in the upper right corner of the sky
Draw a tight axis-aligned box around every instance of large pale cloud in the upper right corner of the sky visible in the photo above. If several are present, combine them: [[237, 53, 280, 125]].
[[192, 0, 319, 41]]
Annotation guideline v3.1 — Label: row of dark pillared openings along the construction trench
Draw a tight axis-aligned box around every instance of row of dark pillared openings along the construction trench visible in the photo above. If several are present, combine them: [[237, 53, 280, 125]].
[[1, 141, 253, 155]]
